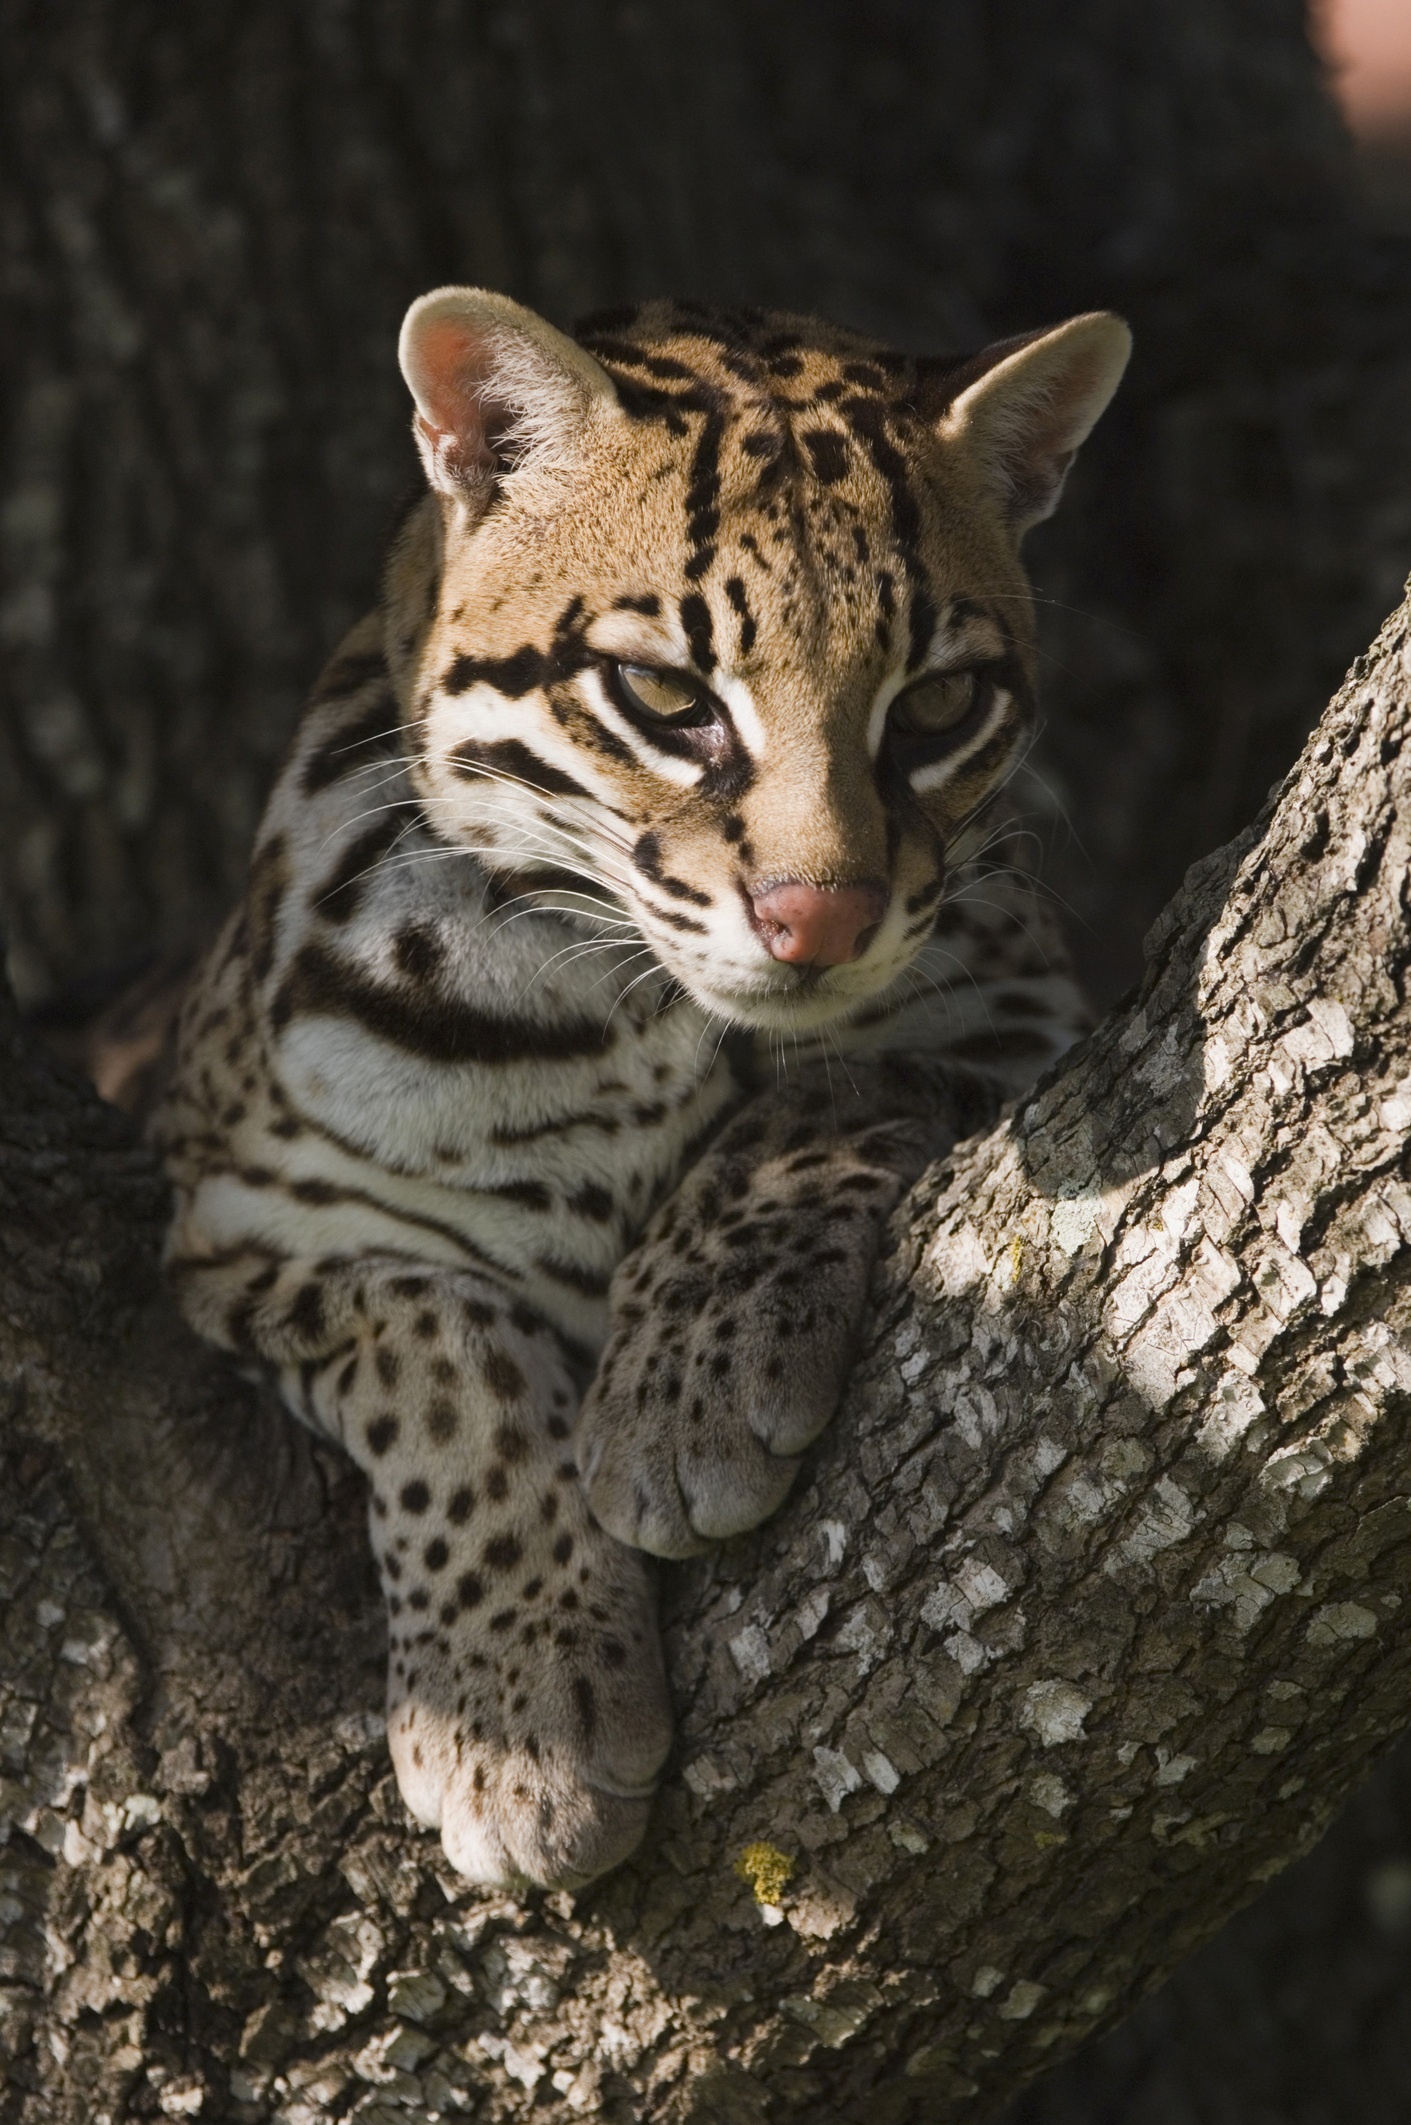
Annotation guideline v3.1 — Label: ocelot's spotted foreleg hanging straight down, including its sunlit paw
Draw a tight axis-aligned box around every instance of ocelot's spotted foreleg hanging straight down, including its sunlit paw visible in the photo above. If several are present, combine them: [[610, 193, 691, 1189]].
[[166, 1256, 669, 1887]]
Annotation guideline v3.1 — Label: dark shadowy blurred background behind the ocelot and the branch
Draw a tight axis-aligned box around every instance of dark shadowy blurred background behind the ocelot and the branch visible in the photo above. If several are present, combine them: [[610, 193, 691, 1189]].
[[0, 0, 1411, 2125]]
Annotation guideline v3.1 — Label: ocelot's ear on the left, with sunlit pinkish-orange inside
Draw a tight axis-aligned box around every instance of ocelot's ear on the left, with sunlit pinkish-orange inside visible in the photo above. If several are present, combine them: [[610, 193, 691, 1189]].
[[397, 287, 618, 516]]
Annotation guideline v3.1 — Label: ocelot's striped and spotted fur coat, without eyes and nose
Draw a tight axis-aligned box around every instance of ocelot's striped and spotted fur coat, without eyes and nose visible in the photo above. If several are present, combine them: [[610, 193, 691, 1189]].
[[153, 289, 1122, 1885]]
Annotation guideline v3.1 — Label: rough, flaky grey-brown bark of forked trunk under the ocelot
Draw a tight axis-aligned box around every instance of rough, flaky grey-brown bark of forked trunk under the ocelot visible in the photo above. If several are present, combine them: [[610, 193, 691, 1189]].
[[0, 539, 1411, 2125]]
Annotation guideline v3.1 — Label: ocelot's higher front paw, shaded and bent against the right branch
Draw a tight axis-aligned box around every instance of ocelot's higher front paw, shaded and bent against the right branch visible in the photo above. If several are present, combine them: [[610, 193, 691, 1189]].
[[574, 1128, 901, 1558]]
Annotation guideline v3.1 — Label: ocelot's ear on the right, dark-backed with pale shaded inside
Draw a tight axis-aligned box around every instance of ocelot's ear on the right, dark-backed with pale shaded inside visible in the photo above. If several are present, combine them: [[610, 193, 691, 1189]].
[[939, 310, 1133, 540]]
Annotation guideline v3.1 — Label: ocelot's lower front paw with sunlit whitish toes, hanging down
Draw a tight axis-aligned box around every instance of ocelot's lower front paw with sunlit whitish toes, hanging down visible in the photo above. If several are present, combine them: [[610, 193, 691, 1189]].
[[383, 1434, 672, 1889]]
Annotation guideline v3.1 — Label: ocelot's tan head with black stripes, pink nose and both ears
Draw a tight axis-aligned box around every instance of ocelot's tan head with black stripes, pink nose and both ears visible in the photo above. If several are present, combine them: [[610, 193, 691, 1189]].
[[389, 287, 1131, 1029]]
